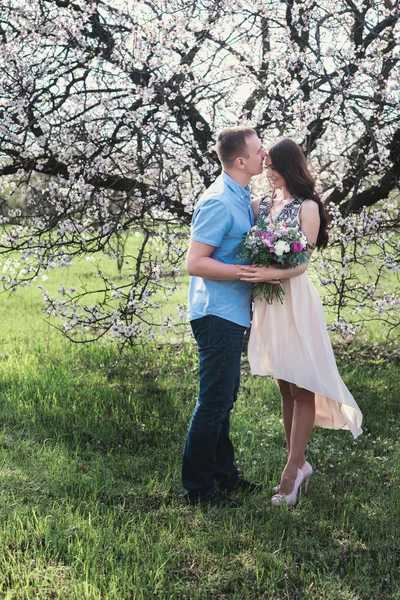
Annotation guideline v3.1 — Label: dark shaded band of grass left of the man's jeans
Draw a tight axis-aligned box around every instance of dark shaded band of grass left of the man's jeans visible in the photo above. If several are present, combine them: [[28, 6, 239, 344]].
[[0, 345, 197, 451]]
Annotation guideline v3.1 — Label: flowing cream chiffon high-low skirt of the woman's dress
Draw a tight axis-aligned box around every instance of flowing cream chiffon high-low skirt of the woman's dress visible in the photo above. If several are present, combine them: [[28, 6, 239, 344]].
[[248, 273, 362, 438]]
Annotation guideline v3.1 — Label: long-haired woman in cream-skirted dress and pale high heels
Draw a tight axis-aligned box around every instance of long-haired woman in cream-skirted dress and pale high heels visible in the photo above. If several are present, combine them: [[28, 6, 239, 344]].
[[239, 139, 362, 505]]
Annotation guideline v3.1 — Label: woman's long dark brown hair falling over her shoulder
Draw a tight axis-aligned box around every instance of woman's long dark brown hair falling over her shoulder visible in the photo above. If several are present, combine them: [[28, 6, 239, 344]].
[[267, 138, 329, 248]]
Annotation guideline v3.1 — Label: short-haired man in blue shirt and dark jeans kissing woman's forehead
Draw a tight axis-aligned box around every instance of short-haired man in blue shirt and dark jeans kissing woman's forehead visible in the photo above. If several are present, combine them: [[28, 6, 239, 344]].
[[182, 127, 266, 504]]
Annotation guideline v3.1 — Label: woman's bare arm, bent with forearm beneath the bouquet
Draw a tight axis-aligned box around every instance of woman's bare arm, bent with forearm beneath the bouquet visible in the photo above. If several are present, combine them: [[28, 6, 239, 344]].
[[238, 200, 320, 283]]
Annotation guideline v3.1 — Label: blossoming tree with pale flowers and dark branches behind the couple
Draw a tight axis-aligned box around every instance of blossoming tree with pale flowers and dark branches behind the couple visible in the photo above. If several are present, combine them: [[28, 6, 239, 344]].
[[0, 0, 400, 341]]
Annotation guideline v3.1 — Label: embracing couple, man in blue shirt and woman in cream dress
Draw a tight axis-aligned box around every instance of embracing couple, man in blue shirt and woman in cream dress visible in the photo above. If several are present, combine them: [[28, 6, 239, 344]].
[[182, 126, 362, 505]]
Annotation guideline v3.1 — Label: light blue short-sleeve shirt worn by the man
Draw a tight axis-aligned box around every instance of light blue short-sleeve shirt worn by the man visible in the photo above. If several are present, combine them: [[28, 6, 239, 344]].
[[188, 172, 254, 327]]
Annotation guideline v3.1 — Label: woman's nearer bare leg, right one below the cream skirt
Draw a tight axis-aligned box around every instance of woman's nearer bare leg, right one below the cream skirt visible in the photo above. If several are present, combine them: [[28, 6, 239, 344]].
[[280, 383, 315, 494]]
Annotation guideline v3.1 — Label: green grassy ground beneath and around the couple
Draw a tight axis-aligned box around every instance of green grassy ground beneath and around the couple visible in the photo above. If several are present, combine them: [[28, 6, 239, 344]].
[[0, 247, 400, 600]]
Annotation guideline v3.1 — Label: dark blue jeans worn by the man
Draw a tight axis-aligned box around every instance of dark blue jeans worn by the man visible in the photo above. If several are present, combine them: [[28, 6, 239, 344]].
[[182, 315, 246, 500]]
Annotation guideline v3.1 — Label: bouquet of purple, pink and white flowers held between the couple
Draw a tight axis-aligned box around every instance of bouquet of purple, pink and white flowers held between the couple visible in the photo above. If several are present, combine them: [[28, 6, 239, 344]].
[[240, 220, 313, 304]]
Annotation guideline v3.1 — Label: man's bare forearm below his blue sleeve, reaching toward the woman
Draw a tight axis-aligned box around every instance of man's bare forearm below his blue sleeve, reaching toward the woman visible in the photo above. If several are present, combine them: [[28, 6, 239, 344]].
[[186, 240, 239, 281]]
